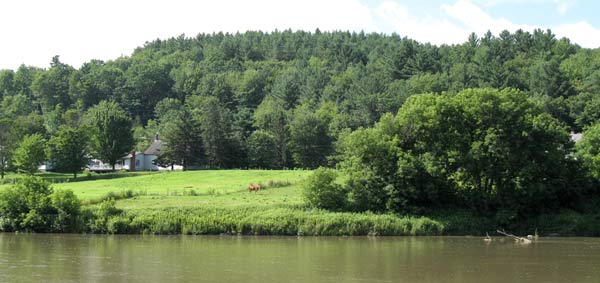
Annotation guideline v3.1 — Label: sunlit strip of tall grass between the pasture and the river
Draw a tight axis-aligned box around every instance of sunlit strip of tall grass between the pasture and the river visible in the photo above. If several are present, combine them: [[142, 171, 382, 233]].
[[81, 207, 444, 236]]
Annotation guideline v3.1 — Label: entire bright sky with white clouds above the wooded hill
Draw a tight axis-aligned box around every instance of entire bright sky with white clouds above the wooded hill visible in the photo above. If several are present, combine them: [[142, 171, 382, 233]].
[[0, 0, 600, 70]]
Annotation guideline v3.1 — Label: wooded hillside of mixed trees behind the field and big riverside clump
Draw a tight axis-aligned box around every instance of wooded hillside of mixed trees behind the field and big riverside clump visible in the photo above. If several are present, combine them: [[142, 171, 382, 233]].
[[0, 30, 600, 175]]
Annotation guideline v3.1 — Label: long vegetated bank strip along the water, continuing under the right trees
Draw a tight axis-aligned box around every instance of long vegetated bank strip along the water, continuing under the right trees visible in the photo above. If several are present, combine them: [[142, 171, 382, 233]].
[[77, 203, 600, 237]]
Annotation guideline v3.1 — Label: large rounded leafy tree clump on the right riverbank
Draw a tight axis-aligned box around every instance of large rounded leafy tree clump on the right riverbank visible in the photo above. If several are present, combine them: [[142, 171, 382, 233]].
[[342, 89, 585, 215]]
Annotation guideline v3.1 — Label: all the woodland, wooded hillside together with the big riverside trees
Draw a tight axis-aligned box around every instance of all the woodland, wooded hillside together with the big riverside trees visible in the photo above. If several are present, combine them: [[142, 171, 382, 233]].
[[0, 30, 600, 218]]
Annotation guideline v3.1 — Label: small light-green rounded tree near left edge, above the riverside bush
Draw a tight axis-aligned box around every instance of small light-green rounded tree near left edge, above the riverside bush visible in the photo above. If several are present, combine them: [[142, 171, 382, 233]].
[[13, 134, 46, 174]]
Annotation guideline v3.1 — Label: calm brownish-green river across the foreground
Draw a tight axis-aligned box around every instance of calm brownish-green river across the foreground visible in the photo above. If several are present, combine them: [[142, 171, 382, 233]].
[[0, 233, 600, 283]]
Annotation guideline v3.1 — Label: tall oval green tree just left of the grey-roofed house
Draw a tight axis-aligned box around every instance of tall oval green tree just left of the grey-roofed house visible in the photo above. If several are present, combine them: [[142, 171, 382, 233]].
[[87, 101, 135, 169]]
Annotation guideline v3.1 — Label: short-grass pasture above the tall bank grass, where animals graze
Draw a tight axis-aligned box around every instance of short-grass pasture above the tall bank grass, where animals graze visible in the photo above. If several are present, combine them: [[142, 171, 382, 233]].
[[53, 170, 312, 209]]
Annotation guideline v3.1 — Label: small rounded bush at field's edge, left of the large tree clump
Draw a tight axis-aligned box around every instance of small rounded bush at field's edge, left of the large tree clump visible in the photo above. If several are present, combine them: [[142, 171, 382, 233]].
[[304, 167, 348, 210]]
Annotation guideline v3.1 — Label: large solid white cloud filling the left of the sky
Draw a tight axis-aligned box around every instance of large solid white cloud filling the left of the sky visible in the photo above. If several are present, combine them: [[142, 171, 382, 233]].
[[0, 0, 377, 69]]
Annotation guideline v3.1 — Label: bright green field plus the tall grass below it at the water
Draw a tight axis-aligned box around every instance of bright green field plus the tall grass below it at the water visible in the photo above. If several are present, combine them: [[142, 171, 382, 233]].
[[0, 170, 443, 235]]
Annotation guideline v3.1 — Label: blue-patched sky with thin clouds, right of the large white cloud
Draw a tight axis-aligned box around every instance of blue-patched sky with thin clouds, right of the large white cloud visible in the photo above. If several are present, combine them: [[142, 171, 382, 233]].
[[360, 0, 600, 48]]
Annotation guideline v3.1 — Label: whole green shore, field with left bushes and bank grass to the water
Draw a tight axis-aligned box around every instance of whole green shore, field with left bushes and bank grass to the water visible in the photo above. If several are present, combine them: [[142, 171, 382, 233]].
[[0, 170, 600, 236]]
